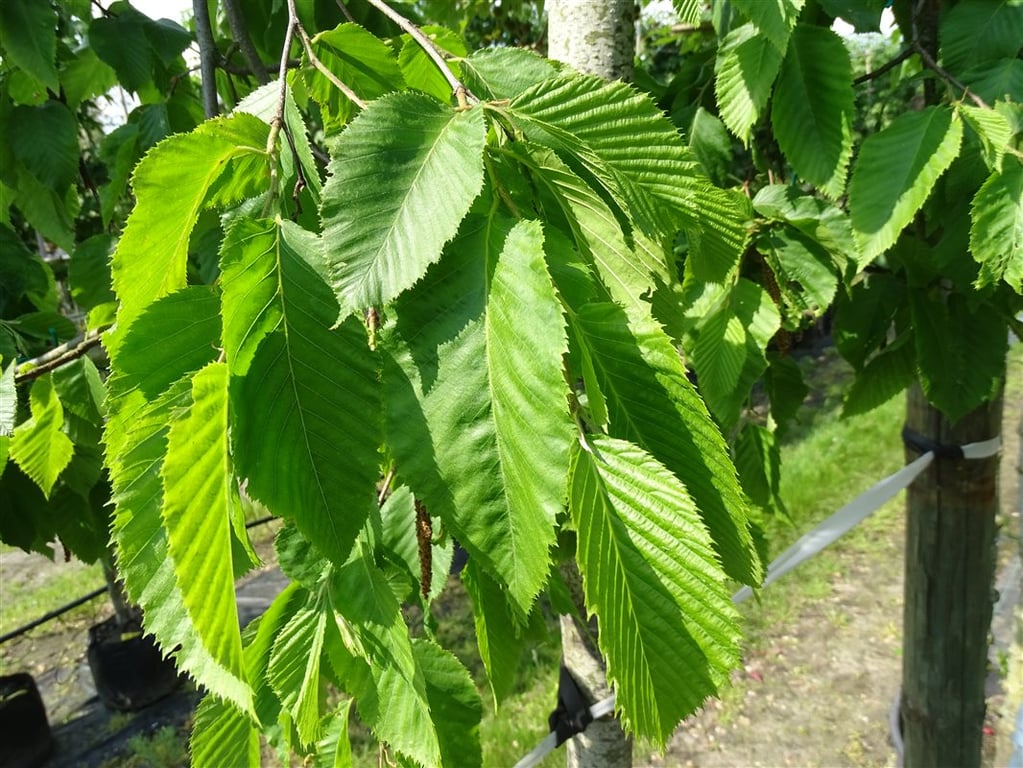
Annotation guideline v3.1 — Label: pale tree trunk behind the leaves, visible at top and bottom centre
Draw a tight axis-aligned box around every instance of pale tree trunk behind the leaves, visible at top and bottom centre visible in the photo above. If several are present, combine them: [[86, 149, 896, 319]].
[[546, 0, 637, 768]]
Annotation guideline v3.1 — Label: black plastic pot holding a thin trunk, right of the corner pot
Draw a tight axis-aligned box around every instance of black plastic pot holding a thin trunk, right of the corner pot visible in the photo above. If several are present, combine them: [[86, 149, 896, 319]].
[[88, 617, 181, 712]]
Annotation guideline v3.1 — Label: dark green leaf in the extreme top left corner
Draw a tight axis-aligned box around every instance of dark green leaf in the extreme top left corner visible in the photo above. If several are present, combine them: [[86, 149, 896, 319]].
[[0, 0, 60, 93]]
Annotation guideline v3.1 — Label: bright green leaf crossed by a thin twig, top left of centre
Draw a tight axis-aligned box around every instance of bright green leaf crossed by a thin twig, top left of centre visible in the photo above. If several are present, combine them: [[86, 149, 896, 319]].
[[303, 24, 404, 134]]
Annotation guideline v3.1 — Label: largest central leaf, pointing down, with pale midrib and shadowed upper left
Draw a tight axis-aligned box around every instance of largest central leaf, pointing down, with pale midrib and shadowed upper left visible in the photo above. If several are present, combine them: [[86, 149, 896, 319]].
[[384, 219, 573, 614]]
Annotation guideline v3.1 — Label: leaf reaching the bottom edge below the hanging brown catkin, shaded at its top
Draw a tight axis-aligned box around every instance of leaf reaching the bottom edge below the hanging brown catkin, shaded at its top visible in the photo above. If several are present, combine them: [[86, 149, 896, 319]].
[[326, 553, 441, 765]]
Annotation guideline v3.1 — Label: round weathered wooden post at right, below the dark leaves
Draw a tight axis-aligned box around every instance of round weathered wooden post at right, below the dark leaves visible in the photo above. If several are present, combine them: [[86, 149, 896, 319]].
[[901, 384, 1002, 768]]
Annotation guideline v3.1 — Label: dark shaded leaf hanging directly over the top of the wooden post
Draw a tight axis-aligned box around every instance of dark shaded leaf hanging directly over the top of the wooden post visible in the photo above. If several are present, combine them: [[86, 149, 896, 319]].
[[908, 290, 1008, 421]]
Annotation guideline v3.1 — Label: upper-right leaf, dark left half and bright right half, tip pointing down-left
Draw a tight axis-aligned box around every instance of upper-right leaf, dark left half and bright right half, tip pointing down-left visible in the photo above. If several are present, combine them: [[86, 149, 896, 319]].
[[849, 106, 963, 263]]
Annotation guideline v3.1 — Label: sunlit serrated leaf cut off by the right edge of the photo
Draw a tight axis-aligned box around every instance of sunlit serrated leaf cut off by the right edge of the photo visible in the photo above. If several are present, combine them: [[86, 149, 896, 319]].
[[970, 157, 1023, 293]]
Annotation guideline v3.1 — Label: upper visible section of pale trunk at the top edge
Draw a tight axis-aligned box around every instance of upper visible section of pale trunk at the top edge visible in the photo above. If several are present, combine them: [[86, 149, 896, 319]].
[[546, 0, 637, 80]]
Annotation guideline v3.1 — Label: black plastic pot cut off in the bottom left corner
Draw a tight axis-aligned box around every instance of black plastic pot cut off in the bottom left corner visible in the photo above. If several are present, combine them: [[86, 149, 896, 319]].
[[0, 673, 53, 768]]
